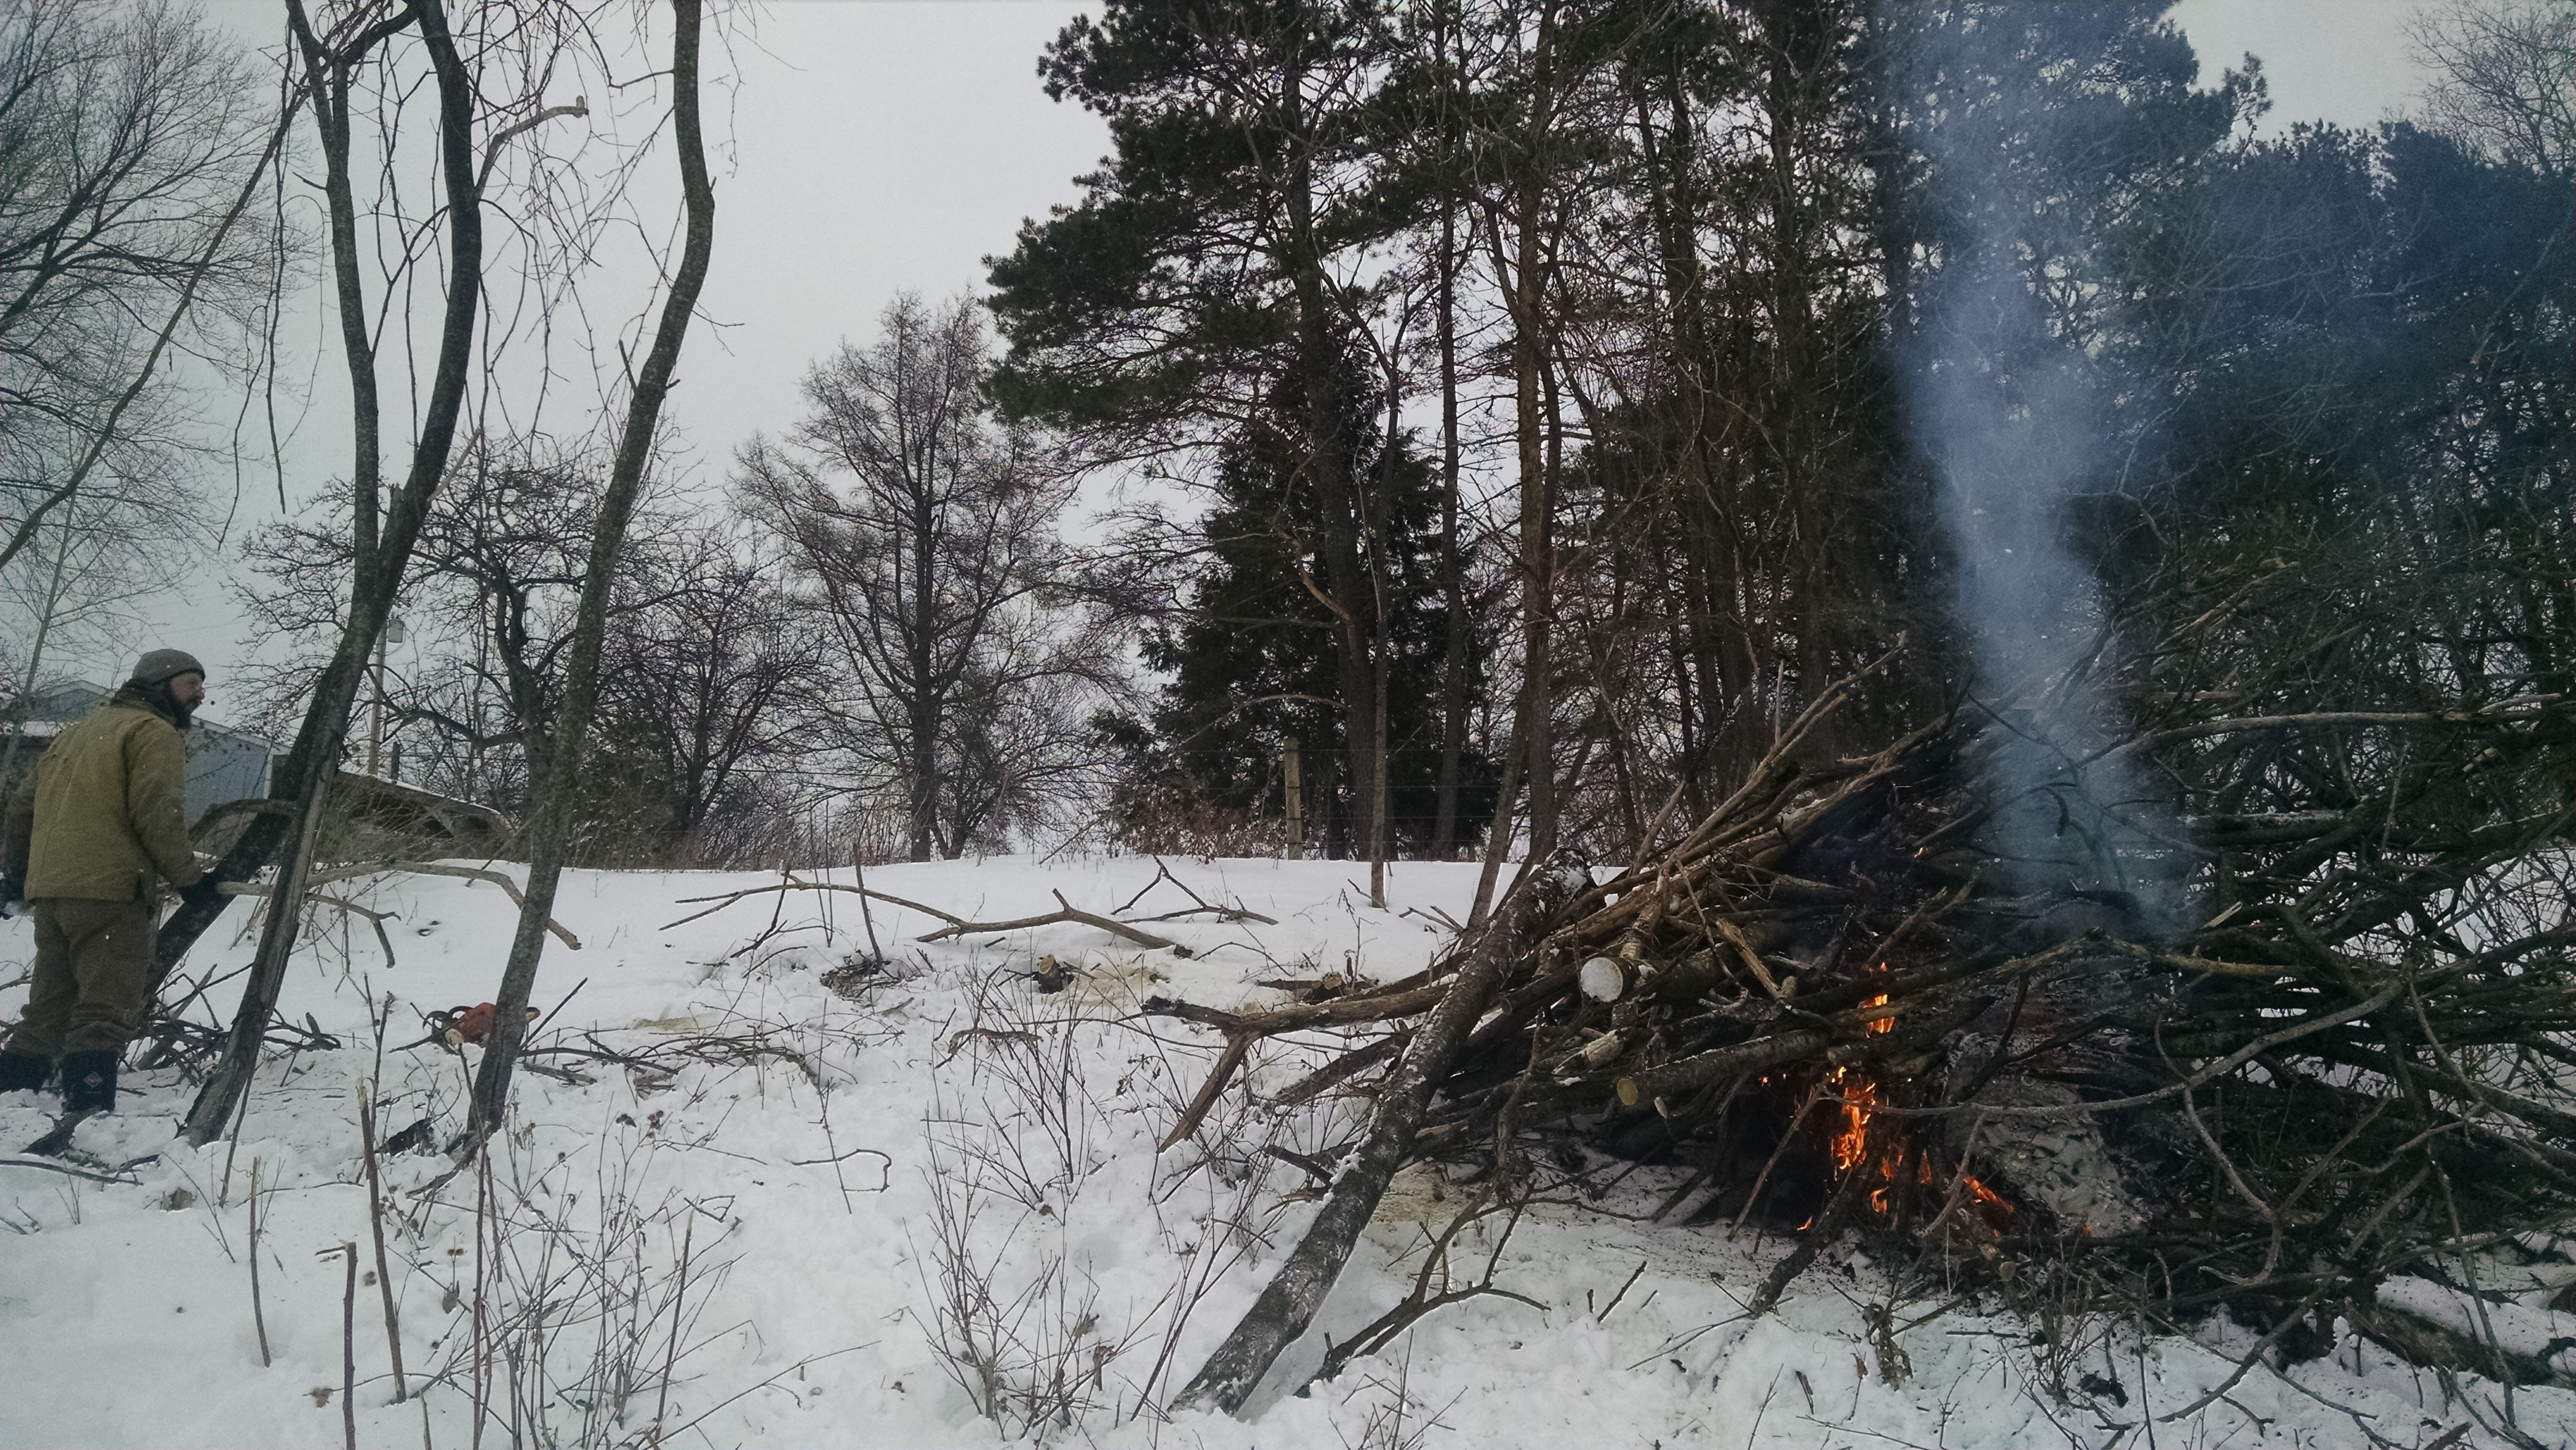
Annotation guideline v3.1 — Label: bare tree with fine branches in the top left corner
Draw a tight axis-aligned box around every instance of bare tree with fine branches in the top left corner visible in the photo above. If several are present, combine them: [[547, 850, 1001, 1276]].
[[0, 0, 286, 564]]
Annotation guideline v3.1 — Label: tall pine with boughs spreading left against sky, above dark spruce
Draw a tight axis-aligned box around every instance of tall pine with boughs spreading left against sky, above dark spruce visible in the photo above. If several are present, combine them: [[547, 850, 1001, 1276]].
[[992, 0, 1401, 875]]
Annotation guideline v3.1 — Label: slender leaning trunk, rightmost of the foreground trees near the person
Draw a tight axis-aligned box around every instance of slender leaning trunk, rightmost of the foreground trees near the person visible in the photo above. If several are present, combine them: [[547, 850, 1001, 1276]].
[[459, 0, 716, 1157]]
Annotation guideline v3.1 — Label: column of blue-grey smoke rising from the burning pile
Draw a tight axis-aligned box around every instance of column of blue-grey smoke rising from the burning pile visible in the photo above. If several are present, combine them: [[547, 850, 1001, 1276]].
[[1903, 26, 2179, 930]]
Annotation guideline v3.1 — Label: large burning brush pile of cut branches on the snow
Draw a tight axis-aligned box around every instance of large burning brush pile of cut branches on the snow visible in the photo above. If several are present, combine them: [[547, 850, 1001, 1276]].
[[1157, 680, 2576, 1403]]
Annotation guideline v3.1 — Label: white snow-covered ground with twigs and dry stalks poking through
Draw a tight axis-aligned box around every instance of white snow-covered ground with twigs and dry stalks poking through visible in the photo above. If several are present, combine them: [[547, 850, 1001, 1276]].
[[0, 857, 2576, 1450]]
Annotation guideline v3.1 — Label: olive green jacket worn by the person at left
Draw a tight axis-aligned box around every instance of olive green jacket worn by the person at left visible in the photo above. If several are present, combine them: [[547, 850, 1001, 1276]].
[[0, 690, 203, 901]]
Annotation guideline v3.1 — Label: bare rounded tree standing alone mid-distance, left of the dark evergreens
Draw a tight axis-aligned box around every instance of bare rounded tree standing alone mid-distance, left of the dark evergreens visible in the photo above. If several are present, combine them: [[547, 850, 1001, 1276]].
[[739, 293, 1100, 860]]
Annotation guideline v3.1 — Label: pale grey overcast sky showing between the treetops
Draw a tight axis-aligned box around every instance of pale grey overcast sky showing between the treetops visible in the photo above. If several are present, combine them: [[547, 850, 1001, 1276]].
[[47, 0, 2424, 718]]
